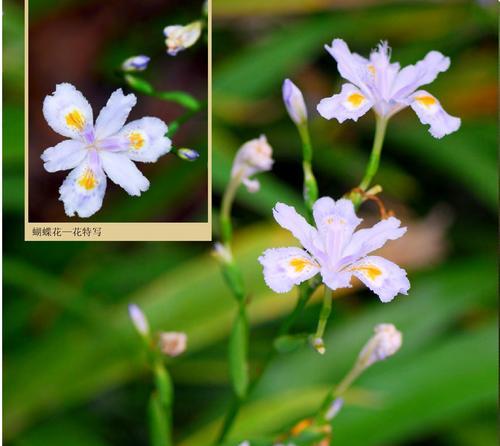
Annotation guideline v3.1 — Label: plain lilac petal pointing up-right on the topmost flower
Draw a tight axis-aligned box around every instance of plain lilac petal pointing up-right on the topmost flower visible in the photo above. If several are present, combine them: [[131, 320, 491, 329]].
[[391, 51, 450, 100]]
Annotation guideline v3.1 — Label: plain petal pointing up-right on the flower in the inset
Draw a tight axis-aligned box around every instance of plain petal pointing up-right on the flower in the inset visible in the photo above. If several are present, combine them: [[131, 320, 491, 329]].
[[95, 88, 137, 139]]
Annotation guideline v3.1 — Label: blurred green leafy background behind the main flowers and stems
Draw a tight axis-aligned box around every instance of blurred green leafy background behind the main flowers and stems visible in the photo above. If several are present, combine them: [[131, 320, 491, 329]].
[[4, 0, 498, 446]]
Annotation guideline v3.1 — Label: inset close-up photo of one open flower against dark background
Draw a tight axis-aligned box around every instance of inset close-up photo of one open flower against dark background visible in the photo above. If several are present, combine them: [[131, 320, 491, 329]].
[[26, 0, 210, 240]]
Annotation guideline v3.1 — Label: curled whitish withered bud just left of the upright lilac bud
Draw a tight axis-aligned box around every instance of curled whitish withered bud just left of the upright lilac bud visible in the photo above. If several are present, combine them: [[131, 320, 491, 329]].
[[231, 135, 274, 193]]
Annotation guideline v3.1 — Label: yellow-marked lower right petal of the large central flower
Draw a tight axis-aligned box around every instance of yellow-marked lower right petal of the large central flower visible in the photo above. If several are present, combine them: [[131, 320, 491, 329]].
[[347, 256, 410, 302]]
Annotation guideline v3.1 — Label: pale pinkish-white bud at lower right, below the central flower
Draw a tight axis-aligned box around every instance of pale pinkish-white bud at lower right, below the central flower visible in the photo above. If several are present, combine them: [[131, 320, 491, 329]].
[[358, 324, 403, 368]]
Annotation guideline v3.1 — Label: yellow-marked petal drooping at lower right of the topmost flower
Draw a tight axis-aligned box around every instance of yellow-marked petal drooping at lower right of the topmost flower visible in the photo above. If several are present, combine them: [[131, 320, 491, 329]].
[[410, 90, 461, 138]]
